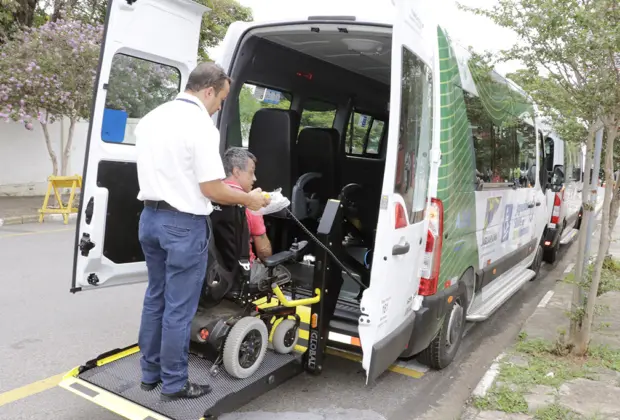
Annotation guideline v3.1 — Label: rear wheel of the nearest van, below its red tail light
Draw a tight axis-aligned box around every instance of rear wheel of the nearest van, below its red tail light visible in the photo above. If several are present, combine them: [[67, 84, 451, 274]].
[[418, 288, 467, 369]]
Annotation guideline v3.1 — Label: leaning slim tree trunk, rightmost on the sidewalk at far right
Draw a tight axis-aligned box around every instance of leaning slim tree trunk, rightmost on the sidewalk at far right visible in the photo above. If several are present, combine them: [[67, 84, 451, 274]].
[[574, 119, 618, 356]]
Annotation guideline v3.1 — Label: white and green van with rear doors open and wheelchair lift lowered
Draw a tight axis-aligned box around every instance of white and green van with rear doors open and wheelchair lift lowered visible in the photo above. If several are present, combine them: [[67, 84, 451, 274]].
[[61, 0, 547, 419]]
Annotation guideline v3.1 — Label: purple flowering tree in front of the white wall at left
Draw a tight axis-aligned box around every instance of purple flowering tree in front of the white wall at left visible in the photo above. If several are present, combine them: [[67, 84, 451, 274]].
[[0, 20, 103, 175]]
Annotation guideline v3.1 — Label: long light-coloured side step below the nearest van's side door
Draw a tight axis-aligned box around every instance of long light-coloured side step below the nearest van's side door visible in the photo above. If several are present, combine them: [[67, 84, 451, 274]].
[[467, 267, 536, 322]]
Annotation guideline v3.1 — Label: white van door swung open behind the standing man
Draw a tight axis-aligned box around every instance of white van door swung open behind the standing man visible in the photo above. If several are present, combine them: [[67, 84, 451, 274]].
[[71, 0, 209, 292]]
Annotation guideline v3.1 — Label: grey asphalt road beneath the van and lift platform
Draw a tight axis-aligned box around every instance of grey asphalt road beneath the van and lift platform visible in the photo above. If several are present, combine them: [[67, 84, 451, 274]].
[[0, 222, 576, 420]]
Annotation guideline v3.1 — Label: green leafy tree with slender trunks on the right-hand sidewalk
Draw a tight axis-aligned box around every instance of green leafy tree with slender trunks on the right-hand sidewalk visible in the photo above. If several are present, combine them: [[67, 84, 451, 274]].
[[459, 0, 620, 355]]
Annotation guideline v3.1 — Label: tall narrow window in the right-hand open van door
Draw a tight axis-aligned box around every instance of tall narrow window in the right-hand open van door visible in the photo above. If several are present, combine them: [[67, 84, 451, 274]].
[[395, 46, 433, 223]]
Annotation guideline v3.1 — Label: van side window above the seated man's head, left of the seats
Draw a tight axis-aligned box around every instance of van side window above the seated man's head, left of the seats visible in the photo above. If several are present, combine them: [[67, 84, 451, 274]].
[[240, 83, 292, 147]]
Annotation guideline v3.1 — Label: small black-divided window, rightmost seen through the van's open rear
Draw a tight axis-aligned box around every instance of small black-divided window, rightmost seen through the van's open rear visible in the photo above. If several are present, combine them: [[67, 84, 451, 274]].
[[346, 112, 385, 157]]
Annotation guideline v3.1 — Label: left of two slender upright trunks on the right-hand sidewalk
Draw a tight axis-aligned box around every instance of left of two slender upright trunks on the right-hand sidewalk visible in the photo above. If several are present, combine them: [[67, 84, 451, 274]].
[[568, 122, 598, 347]]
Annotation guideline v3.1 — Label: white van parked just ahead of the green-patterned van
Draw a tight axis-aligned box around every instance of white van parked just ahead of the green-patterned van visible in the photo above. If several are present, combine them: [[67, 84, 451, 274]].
[[543, 127, 585, 263]]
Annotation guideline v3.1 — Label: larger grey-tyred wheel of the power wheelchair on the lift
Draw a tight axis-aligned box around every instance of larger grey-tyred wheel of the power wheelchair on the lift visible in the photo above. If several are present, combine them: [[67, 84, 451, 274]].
[[223, 316, 269, 379]]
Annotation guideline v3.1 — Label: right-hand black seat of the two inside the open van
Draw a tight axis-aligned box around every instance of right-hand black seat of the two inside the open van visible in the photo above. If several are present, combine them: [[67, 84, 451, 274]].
[[292, 127, 342, 220]]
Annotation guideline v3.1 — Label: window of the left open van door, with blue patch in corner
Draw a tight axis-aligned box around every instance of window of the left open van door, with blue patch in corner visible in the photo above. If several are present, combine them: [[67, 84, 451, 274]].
[[101, 54, 181, 145]]
